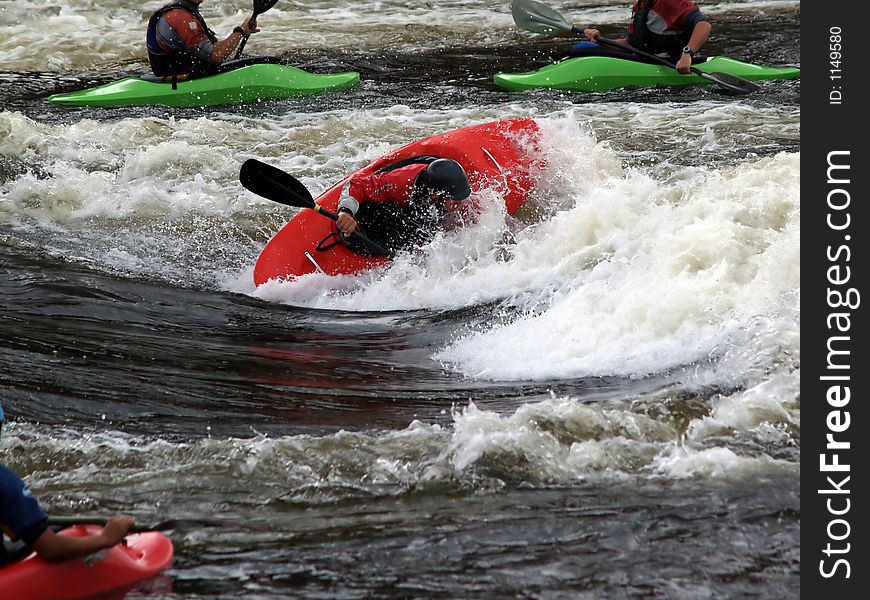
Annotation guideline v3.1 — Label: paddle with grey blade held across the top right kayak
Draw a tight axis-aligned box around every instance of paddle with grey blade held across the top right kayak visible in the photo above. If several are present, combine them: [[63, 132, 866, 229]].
[[511, 0, 761, 94]]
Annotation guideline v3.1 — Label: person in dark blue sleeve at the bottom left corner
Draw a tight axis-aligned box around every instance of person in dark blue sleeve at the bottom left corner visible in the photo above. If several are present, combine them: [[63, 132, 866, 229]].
[[0, 406, 133, 564]]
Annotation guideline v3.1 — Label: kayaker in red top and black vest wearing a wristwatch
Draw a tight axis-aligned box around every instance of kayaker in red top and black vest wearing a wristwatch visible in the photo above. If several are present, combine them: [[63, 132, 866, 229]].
[[567, 0, 712, 75]]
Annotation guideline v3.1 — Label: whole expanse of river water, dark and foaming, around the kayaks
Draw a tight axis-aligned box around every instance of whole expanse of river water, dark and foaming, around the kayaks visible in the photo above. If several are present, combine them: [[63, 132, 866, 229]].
[[0, 0, 800, 599]]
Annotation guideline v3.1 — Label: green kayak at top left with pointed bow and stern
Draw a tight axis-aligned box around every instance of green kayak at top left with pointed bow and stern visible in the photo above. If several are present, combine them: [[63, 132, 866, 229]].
[[48, 63, 359, 107]]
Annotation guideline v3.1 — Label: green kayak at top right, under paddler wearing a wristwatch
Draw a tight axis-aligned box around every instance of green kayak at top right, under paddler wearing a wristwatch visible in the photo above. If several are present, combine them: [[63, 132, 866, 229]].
[[494, 56, 800, 92]]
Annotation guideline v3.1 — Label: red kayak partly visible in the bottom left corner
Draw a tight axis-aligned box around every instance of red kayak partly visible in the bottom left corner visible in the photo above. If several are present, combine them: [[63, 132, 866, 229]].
[[0, 525, 173, 600]]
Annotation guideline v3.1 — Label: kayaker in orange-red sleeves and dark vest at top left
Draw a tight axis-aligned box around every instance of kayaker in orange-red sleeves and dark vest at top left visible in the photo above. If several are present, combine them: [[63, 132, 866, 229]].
[[146, 0, 260, 77]]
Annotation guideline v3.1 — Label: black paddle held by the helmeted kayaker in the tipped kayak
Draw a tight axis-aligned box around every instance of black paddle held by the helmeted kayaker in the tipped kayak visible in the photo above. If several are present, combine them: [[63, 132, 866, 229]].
[[239, 158, 393, 257]]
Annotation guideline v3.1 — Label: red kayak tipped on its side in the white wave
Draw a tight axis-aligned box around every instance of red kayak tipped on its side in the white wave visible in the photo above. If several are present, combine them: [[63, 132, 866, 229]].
[[254, 119, 544, 285]]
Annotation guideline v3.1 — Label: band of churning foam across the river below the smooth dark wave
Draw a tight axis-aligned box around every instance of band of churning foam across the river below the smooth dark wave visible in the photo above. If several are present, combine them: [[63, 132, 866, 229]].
[[0, 376, 799, 496]]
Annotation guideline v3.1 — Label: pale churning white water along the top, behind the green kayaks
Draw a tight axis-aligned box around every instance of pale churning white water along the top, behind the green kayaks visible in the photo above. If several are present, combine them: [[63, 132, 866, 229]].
[[0, 0, 800, 73]]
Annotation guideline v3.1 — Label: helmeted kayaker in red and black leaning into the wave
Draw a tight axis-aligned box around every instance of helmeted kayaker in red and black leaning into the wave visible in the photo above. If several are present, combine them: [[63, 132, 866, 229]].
[[336, 155, 475, 252]]
